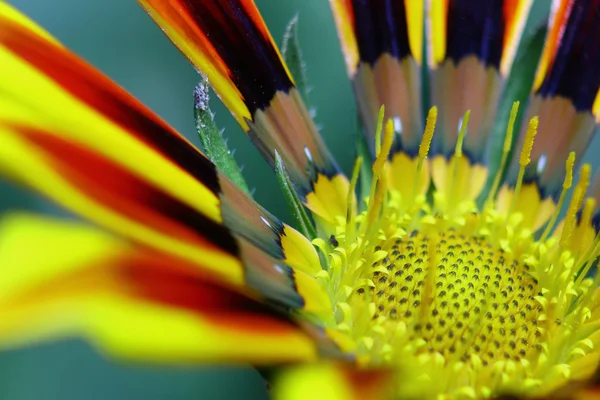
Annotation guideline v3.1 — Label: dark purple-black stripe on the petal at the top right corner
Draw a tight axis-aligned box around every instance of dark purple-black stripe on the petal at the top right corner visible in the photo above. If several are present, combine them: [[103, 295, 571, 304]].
[[537, 0, 600, 111]]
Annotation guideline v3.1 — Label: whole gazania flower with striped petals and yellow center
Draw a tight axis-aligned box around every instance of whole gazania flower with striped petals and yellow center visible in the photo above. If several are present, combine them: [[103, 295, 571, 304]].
[[0, 0, 600, 399]]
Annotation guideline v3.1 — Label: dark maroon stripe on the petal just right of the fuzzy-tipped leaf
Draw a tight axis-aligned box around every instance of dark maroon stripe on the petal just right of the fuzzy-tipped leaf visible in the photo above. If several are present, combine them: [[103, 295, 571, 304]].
[[179, 0, 294, 115]]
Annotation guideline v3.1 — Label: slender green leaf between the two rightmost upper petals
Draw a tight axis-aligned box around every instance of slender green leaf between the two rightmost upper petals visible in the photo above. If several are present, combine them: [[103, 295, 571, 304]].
[[479, 22, 546, 202]]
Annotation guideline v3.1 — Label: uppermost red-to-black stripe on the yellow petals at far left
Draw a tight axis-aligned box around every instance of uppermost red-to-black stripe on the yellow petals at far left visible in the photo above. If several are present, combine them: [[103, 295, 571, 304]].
[[0, 25, 219, 193]]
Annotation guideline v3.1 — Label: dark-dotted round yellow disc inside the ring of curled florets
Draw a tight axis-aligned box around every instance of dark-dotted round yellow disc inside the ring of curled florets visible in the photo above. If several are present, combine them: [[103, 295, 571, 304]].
[[368, 230, 542, 366]]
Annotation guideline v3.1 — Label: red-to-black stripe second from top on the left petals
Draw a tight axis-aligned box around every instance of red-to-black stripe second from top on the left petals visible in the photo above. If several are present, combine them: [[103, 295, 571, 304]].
[[23, 127, 239, 256]]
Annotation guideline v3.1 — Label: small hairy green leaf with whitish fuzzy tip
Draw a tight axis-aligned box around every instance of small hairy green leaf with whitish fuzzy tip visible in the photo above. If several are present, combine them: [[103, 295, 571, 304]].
[[194, 77, 250, 194]]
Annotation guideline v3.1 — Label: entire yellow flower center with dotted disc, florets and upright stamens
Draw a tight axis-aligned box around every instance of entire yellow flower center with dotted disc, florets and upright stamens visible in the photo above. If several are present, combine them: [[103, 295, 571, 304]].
[[315, 107, 600, 398]]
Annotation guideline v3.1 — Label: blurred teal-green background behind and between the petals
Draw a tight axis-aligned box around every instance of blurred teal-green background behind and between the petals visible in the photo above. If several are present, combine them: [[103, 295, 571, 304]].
[[0, 0, 356, 400]]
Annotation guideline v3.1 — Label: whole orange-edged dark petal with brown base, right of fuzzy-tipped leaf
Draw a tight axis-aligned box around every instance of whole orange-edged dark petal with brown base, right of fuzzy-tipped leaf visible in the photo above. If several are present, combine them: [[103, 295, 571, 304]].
[[138, 0, 338, 194]]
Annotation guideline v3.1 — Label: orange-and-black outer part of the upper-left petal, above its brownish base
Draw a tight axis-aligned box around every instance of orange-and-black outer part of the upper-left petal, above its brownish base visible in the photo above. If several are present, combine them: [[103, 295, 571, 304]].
[[139, 0, 294, 131]]
